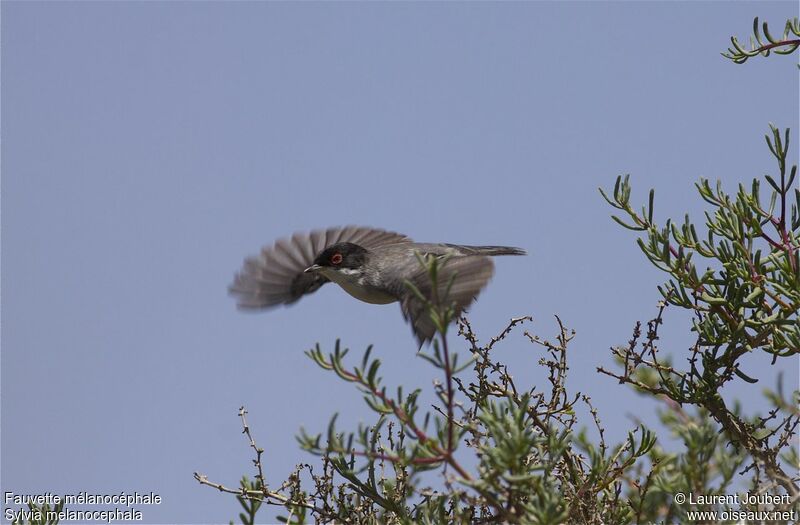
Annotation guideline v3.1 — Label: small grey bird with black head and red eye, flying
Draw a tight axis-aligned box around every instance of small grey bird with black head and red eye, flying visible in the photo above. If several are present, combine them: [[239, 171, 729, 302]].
[[228, 226, 527, 347]]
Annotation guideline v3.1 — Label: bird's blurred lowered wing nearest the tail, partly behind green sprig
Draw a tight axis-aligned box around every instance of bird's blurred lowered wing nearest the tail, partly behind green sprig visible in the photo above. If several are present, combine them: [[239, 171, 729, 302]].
[[399, 256, 494, 345]]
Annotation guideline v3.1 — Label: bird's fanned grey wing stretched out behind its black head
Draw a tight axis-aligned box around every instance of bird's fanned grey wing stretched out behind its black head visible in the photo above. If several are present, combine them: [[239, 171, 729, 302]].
[[228, 226, 411, 309]]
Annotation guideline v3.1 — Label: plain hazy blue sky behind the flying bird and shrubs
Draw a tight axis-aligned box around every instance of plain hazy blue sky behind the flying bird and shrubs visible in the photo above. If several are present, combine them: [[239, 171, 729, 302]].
[[0, 1, 800, 523]]
